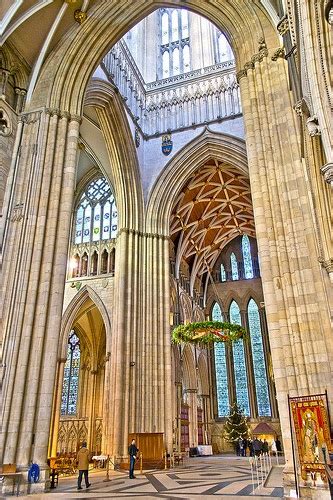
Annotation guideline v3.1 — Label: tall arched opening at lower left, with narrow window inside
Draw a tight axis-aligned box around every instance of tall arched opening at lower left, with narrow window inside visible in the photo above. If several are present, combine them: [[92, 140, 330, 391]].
[[49, 296, 107, 457]]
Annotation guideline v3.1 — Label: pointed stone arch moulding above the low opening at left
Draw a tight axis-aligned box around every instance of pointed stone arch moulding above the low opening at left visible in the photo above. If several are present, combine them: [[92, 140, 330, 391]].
[[58, 285, 111, 359]]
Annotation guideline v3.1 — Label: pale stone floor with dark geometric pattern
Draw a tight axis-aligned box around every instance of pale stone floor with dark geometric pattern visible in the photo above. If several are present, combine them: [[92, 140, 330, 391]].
[[13, 456, 283, 500]]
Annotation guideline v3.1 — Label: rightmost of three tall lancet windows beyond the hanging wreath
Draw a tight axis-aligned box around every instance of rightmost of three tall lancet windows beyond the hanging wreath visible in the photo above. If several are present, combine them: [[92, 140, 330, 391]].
[[247, 299, 271, 417]]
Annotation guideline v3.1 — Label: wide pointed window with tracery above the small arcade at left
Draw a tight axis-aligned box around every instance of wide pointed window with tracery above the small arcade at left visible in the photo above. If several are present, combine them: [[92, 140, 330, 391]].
[[75, 177, 118, 243]]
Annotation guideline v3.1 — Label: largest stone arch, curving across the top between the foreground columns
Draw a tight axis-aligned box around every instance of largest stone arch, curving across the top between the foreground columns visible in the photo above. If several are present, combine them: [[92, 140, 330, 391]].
[[30, 0, 279, 114]]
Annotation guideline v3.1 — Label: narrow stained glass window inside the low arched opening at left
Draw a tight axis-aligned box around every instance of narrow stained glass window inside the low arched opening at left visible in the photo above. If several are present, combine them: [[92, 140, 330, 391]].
[[61, 330, 80, 415]]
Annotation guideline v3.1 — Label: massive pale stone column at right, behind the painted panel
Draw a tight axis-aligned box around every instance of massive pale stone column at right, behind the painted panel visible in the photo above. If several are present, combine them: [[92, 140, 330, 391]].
[[238, 40, 333, 488]]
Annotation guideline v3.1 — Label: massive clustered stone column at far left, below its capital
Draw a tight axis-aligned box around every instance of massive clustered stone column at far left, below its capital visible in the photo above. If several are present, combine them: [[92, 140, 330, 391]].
[[2, 110, 80, 494]]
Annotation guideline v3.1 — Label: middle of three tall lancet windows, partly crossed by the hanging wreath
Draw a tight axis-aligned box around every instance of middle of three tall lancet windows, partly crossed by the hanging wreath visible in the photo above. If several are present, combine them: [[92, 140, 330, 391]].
[[229, 300, 250, 416]]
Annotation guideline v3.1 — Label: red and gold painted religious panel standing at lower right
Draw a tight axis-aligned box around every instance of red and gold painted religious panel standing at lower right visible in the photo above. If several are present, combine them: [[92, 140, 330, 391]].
[[289, 395, 331, 479]]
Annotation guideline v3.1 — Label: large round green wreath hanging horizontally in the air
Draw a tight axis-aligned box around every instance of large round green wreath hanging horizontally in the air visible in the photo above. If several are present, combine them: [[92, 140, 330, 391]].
[[172, 321, 246, 346]]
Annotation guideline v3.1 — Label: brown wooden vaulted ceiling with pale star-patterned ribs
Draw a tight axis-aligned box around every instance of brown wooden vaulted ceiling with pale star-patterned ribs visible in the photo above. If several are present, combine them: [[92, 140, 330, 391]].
[[170, 159, 255, 276]]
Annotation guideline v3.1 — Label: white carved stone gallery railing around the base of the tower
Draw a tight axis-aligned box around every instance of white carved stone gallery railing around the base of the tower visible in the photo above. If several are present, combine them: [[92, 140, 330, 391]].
[[101, 41, 242, 139]]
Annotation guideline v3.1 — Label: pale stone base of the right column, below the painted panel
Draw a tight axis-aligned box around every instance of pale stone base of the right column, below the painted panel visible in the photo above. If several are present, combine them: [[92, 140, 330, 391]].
[[283, 466, 331, 500]]
